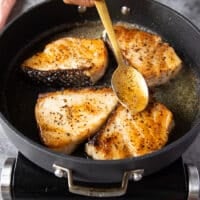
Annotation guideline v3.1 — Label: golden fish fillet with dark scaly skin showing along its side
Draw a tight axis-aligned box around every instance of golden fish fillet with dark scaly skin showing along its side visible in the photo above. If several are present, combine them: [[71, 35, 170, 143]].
[[21, 37, 108, 86]]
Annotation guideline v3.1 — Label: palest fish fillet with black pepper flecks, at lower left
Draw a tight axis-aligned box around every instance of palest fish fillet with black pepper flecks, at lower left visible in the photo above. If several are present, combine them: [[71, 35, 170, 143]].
[[35, 88, 117, 153]]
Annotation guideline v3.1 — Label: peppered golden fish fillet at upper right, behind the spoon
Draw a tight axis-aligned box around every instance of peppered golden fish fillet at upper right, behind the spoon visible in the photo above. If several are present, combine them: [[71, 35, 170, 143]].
[[114, 26, 182, 87]]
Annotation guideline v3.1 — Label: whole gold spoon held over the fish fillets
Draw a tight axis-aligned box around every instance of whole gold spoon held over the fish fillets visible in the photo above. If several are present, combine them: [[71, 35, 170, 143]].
[[95, 0, 149, 114]]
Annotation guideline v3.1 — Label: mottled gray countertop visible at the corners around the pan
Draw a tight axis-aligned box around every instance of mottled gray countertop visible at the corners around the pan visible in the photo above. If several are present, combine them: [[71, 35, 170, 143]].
[[0, 0, 200, 192]]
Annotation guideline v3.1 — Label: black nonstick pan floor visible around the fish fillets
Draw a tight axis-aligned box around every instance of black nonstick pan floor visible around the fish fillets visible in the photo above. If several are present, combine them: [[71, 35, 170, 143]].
[[0, 18, 198, 157]]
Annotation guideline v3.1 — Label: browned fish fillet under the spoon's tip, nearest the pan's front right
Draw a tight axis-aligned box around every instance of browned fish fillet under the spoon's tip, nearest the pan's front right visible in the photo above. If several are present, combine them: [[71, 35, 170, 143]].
[[86, 103, 173, 160]]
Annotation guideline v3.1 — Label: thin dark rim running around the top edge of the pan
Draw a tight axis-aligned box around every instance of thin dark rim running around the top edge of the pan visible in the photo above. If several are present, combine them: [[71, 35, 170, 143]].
[[0, 0, 200, 166]]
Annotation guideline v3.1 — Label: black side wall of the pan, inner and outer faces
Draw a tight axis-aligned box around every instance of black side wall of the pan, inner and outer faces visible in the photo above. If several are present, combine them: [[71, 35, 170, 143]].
[[0, 0, 200, 182]]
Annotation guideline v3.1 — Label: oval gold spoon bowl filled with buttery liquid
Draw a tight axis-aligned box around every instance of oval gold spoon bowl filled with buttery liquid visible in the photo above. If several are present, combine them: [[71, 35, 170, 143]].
[[111, 65, 149, 115]]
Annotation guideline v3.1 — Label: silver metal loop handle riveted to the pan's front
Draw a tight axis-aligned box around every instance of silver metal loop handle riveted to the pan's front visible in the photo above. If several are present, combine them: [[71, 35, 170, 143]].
[[53, 164, 144, 197]]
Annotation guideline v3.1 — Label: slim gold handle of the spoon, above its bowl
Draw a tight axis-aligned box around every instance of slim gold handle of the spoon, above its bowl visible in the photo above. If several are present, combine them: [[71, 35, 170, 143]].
[[94, 0, 124, 66]]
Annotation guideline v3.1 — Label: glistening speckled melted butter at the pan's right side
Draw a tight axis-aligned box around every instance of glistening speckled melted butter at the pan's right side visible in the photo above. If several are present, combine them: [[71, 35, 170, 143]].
[[154, 66, 199, 123]]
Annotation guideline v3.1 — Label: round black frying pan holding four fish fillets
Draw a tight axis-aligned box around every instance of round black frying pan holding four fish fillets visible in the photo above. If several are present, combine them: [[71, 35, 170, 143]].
[[0, 0, 200, 197]]
